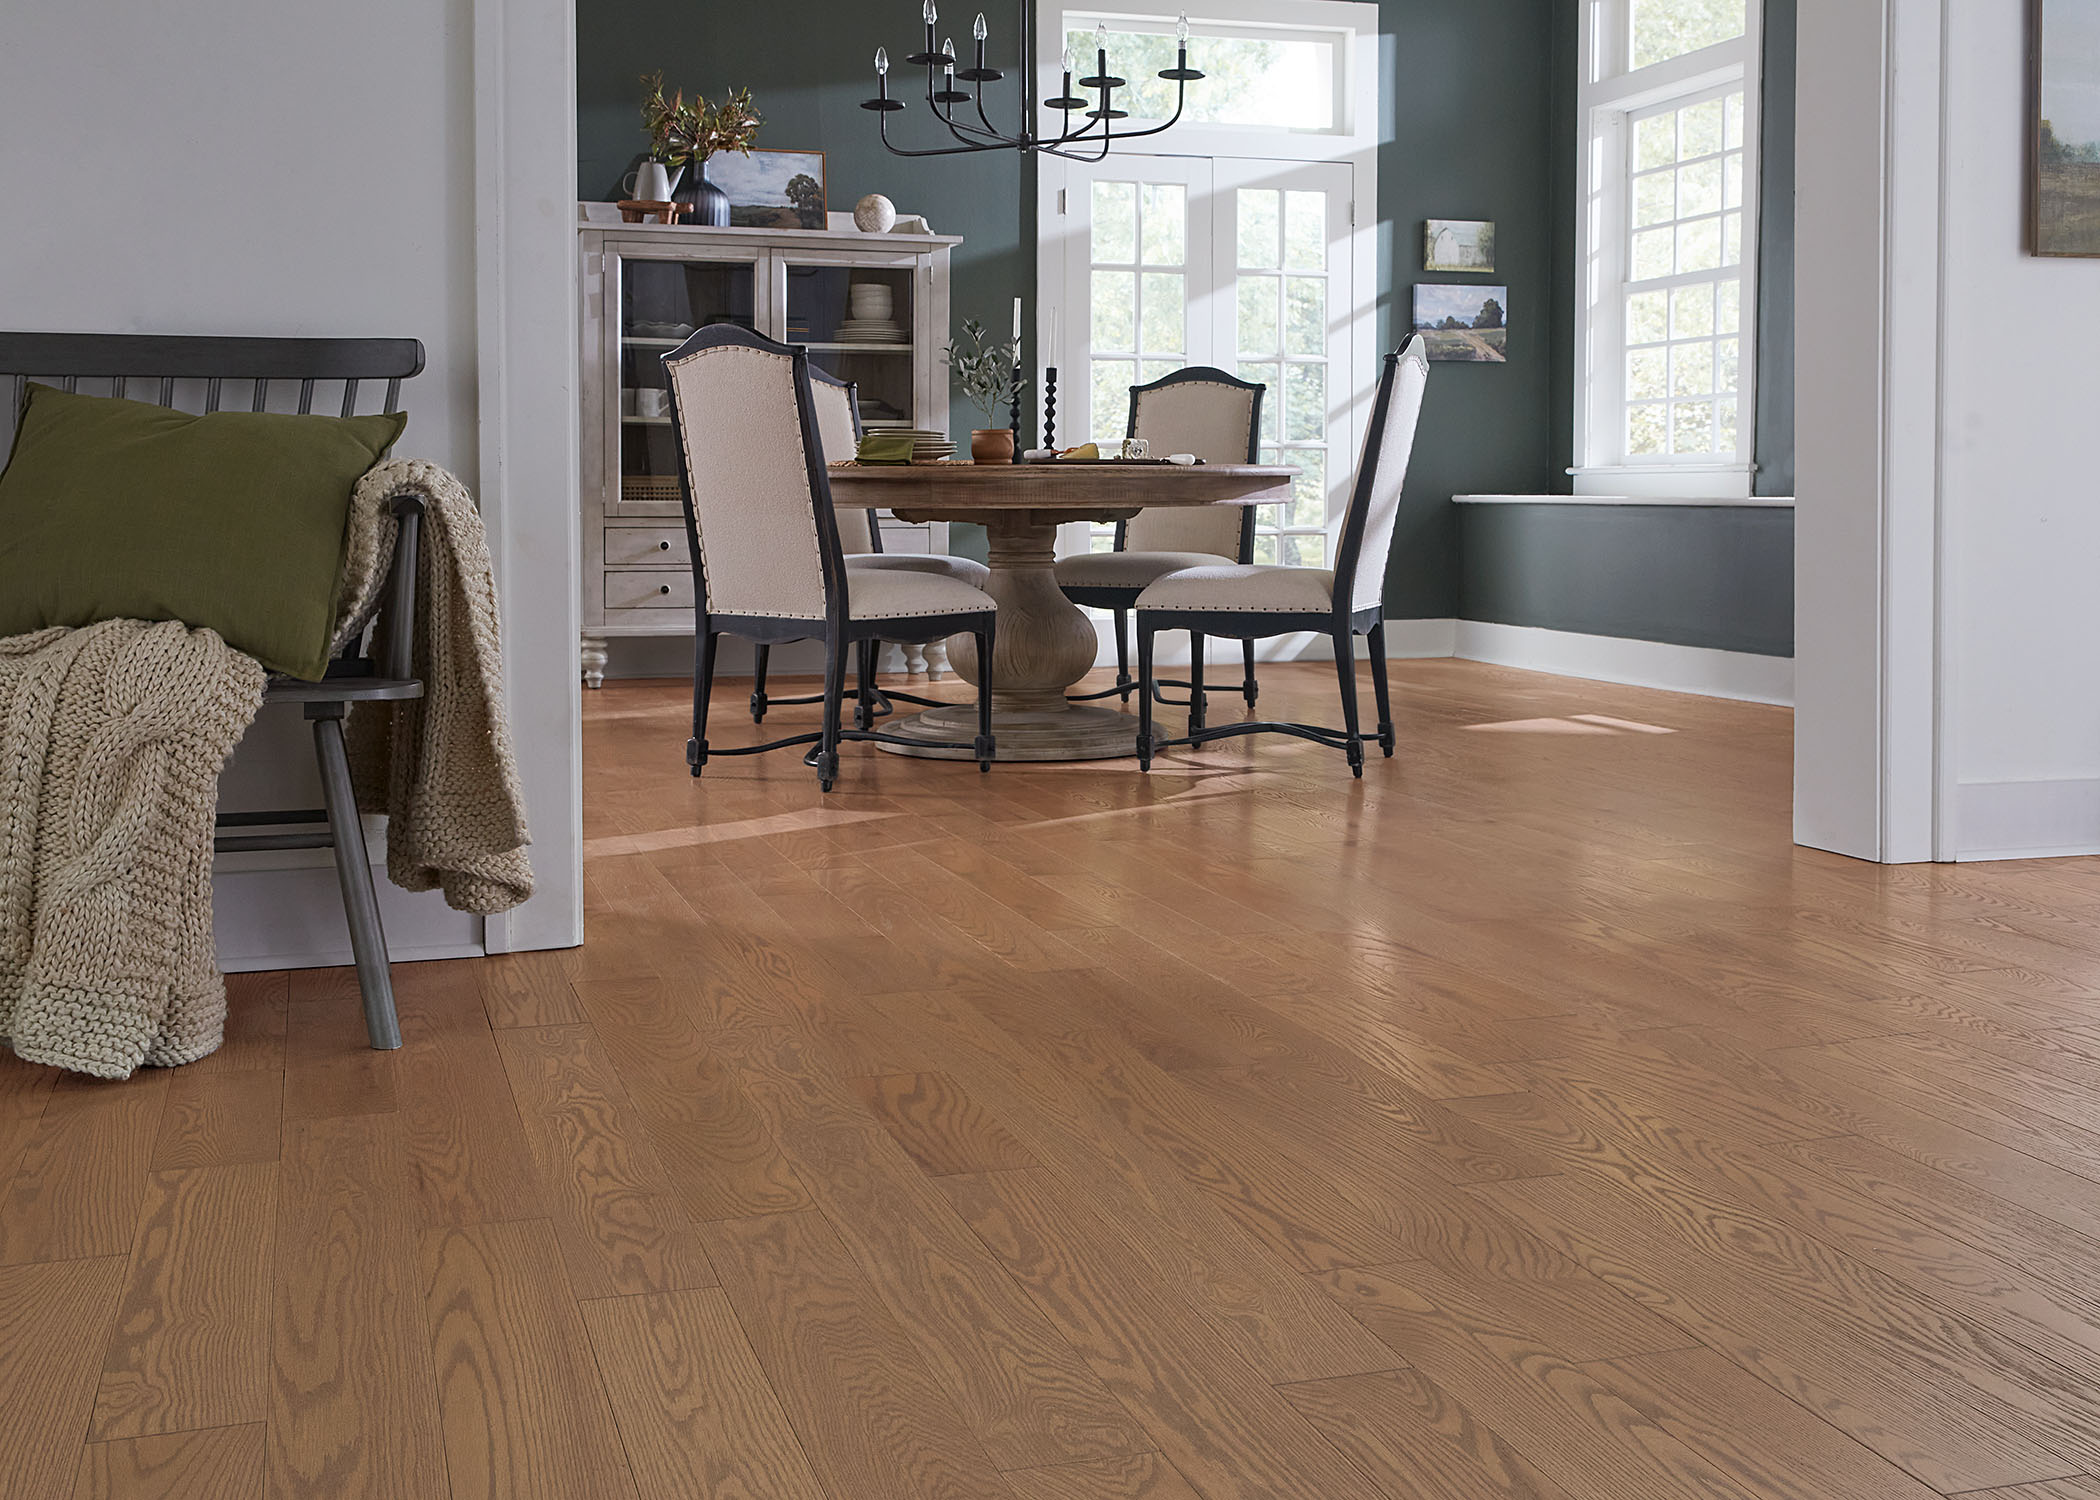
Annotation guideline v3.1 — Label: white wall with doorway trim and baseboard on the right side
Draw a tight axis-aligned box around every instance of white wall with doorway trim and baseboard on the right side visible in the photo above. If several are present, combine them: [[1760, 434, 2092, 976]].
[[1796, 0, 2100, 861]]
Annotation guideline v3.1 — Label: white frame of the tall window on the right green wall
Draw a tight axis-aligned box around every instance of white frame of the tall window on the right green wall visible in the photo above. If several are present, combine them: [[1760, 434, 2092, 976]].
[[1569, 0, 1764, 500]]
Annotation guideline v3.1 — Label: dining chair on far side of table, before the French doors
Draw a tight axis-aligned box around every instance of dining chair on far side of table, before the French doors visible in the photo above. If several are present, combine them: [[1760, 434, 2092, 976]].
[[1056, 366, 1266, 708]]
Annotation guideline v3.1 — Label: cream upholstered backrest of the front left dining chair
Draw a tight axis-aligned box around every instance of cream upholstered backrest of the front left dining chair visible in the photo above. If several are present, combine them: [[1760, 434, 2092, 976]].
[[664, 324, 844, 620]]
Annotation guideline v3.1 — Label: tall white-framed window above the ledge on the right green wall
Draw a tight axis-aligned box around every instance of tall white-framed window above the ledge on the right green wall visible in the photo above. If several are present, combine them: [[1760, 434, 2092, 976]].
[[1575, 0, 1760, 498]]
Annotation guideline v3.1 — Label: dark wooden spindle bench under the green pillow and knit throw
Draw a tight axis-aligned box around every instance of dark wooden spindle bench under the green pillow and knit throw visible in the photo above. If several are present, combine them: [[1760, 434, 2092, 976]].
[[0, 334, 424, 1050]]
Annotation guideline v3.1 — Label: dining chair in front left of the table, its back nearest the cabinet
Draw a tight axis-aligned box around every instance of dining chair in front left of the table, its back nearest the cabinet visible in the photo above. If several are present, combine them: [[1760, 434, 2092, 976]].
[[664, 324, 998, 792]]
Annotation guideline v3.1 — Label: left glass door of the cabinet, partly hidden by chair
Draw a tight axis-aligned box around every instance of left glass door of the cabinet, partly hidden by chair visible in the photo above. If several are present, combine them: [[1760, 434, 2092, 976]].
[[617, 256, 758, 513]]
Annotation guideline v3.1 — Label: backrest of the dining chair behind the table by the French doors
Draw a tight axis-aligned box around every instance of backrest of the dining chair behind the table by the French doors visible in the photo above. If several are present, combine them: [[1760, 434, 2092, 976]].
[[1119, 366, 1266, 561]]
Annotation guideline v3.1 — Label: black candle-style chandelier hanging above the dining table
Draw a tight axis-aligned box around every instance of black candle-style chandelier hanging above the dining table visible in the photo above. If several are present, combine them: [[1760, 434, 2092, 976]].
[[861, 0, 1203, 162]]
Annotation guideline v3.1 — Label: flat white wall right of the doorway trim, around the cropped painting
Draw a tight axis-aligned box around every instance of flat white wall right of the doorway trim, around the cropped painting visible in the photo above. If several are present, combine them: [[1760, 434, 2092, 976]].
[[1943, 0, 2100, 857]]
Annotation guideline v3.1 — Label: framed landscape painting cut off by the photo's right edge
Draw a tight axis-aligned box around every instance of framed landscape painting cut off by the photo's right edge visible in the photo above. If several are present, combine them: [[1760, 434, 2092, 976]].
[[2029, 0, 2100, 256]]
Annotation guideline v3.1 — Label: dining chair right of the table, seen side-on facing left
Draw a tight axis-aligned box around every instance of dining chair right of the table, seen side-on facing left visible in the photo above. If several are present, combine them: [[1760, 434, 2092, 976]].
[[1138, 334, 1430, 777]]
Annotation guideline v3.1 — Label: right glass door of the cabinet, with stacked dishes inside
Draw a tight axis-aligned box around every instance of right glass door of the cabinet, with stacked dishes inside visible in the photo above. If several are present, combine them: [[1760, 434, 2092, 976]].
[[785, 263, 920, 434]]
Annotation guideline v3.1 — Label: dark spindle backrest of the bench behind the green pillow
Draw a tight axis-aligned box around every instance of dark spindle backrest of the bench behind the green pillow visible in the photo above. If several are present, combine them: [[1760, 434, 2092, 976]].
[[0, 334, 422, 679]]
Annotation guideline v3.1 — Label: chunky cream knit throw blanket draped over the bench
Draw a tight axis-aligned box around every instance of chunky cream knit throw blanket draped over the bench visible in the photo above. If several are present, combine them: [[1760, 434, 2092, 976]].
[[0, 462, 531, 1078]]
